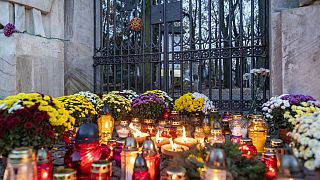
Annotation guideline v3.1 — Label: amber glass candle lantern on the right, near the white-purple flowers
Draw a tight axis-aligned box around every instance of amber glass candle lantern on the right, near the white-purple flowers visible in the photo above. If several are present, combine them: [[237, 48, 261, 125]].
[[248, 116, 268, 153]]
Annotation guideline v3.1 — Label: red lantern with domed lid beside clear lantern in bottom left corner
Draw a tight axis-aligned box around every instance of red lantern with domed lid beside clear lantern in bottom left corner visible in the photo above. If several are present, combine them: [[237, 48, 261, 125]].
[[37, 148, 53, 180]]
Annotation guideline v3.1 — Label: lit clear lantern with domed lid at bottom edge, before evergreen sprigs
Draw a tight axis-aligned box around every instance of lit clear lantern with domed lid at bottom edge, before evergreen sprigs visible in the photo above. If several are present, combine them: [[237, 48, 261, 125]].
[[204, 148, 227, 180]]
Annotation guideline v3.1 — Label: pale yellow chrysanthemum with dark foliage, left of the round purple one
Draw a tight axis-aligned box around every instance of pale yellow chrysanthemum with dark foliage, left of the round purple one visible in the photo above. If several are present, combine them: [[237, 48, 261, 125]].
[[98, 91, 131, 120]]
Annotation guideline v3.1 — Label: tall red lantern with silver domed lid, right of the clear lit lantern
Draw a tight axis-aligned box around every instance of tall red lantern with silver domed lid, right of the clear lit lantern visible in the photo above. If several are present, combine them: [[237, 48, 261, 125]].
[[142, 137, 160, 180]]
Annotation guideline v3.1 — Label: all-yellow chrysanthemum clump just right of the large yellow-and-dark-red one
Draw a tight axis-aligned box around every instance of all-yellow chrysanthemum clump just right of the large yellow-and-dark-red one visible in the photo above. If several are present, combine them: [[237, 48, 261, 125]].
[[57, 95, 97, 126]]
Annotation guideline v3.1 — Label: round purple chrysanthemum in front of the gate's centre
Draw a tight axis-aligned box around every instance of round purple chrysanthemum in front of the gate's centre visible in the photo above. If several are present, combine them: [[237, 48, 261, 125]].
[[131, 93, 167, 120]]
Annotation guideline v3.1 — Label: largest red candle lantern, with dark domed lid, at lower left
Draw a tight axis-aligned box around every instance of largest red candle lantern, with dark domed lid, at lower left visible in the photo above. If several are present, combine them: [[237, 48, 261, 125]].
[[64, 123, 110, 174]]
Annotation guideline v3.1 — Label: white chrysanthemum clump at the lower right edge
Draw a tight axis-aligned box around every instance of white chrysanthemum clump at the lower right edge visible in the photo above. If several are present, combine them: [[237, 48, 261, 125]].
[[290, 112, 320, 170]]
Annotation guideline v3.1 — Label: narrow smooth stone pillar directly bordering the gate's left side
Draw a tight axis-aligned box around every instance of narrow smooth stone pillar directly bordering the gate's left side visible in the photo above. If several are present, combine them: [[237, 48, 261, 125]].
[[65, 0, 95, 94]]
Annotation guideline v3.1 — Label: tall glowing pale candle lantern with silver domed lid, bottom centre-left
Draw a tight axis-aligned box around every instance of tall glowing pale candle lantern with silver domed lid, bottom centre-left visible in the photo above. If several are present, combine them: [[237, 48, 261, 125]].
[[121, 137, 138, 180]]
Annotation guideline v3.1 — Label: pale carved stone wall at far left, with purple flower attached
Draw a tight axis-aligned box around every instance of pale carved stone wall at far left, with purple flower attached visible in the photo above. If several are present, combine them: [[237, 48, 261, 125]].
[[0, 0, 64, 98]]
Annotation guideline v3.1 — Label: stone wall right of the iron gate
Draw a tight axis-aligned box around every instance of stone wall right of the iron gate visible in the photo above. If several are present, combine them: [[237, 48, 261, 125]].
[[270, 0, 320, 98]]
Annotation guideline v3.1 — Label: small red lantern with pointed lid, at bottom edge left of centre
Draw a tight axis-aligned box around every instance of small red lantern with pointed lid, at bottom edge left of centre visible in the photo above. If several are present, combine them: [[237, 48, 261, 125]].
[[132, 153, 150, 180]]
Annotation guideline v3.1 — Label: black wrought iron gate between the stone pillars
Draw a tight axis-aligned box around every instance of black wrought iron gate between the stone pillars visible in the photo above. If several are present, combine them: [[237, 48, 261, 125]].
[[94, 0, 269, 111]]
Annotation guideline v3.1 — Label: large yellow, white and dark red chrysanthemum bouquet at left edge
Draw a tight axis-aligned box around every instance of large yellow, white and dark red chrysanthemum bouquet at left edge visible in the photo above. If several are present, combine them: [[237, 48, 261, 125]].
[[0, 93, 74, 156]]
